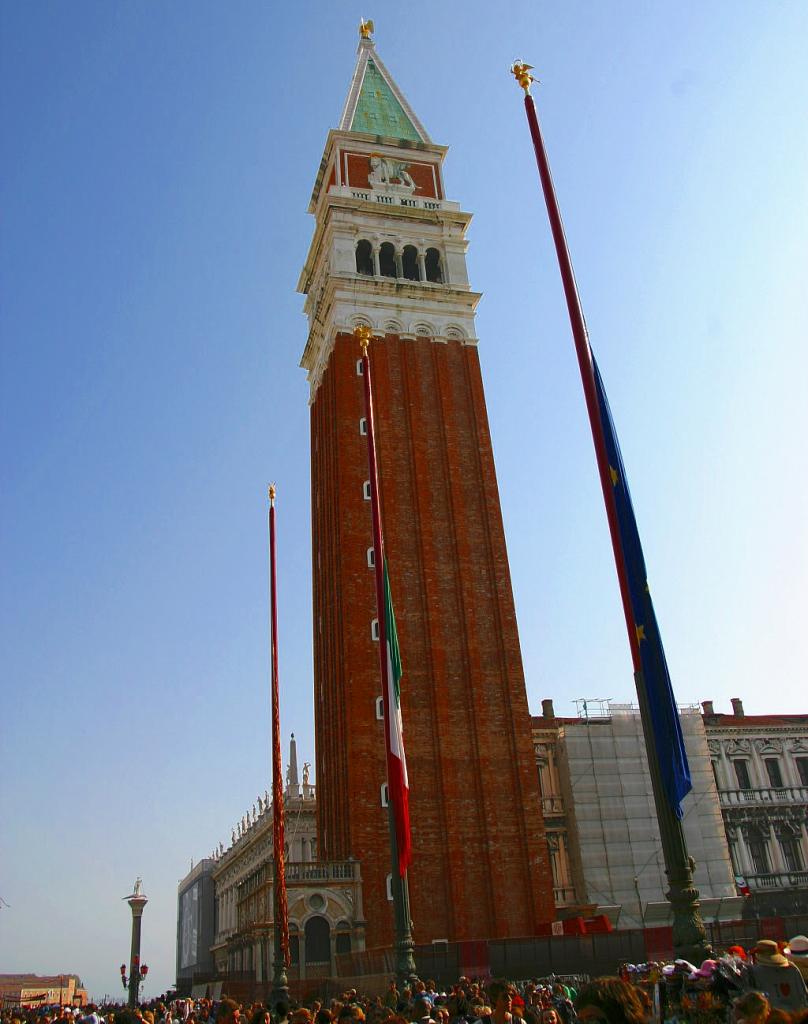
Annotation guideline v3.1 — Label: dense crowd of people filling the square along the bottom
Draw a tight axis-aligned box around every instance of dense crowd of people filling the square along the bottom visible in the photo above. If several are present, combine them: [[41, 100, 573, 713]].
[[6, 935, 808, 1024]]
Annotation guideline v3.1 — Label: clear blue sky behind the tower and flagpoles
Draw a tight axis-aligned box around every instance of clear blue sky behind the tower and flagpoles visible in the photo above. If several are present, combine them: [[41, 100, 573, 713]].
[[0, 0, 808, 996]]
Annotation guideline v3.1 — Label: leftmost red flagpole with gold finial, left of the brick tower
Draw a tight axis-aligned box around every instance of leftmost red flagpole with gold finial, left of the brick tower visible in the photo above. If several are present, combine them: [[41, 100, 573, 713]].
[[269, 484, 290, 966]]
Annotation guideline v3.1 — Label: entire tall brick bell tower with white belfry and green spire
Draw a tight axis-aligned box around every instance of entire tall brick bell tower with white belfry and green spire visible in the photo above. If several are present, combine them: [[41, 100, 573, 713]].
[[298, 24, 554, 948]]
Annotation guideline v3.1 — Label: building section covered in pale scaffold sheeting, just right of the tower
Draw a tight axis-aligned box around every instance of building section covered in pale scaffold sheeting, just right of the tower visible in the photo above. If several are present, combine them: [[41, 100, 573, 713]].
[[533, 700, 743, 928]]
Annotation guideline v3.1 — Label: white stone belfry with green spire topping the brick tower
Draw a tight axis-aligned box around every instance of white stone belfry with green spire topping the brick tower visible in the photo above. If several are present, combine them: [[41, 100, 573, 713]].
[[298, 32, 480, 401]]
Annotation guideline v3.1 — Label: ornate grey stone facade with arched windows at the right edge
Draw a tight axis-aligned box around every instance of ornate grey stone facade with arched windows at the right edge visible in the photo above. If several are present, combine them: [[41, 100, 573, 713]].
[[701, 697, 808, 916]]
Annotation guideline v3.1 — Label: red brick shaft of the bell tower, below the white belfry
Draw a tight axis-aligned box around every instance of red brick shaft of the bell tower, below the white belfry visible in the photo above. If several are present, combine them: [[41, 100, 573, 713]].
[[311, 335, 554, 947]]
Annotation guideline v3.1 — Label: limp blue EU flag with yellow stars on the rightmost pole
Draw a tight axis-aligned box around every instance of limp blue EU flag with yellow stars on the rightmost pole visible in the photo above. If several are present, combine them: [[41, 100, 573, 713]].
[[592, 355, 692, 818]]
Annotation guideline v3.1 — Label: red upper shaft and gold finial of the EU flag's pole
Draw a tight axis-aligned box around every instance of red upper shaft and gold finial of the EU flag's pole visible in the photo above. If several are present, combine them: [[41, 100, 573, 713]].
[[511, 63, 641, 672]]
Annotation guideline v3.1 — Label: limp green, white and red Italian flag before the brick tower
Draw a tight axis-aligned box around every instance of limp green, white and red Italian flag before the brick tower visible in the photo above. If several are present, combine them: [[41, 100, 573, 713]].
[[383, 558, 412, 878]]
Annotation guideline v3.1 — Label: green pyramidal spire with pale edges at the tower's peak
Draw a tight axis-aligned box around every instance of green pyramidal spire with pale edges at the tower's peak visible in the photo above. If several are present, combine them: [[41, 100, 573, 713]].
[[340, 29, 430, 142]]
